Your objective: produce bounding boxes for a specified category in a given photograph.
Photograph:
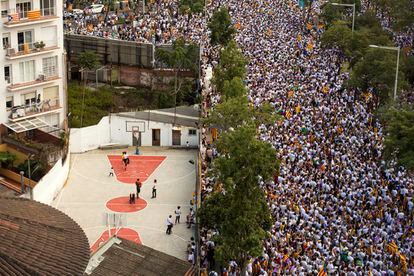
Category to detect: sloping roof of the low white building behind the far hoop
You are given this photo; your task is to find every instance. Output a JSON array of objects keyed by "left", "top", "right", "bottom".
[{"left": 117, "top": 106, "right": 199, "bottom": 128}]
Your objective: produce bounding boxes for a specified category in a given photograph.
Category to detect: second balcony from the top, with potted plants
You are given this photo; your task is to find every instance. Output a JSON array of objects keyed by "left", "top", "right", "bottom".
[{"left": 6, "top": 41, "right": 59, "bottom": 60}]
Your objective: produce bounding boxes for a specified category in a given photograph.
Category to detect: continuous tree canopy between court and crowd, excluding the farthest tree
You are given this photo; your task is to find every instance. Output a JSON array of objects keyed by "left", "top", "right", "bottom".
[{"left": 198, "top": 34, "right": 279, "bottom": 269}]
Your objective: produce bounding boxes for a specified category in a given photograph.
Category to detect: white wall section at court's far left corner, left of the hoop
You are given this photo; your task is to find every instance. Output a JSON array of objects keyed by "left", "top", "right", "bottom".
[{"left": 69, "top": 116, "right": 110, "bottom": 153}]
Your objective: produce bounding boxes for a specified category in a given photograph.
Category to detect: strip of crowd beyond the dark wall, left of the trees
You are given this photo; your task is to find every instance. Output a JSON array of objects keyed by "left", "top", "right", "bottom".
[{"left": 64, "top": 0, "right": 206, "bottom": 44}]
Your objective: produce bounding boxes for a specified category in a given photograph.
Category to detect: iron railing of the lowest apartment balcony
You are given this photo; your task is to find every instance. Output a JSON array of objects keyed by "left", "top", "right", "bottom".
[{"left": 10, "top": 98, "right": 60, "bottom": 119}]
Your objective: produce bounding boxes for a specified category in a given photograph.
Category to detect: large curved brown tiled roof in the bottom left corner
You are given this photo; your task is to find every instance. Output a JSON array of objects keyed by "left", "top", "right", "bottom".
[{"left": 0, "top": 197, "right": 90, "bottom": 276}]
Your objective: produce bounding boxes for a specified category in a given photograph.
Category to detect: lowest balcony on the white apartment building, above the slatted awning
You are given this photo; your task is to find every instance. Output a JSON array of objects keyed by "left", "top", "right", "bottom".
[{"left": 9, "top": 99, "right": 62, "bottom": 122}]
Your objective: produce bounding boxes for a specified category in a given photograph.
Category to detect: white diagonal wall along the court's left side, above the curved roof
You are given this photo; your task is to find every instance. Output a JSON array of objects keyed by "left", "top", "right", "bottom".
[{"left": 33, "top": 153, "right": 70, "bottom": 204}]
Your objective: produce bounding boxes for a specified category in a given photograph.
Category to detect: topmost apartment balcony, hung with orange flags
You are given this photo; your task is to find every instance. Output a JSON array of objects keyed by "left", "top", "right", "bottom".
[{"left": 3, "top": 8, "right": 59, "bottom": 29}]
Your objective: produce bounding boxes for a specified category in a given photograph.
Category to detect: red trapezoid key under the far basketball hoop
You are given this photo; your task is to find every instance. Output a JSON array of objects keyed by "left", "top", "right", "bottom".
[{"left": 108, "top": 155, "right": 166, "bottom": 184}]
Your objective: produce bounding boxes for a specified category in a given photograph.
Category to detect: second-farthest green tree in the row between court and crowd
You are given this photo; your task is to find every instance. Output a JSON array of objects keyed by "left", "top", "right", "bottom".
[{"left": 213, "top": 40, "right": 247, "bottom": 92}]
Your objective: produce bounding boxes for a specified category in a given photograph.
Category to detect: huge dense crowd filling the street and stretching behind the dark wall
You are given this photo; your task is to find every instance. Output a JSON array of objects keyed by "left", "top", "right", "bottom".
[{"left": 65, "top": 0, "right": 414, "bottom": 275}]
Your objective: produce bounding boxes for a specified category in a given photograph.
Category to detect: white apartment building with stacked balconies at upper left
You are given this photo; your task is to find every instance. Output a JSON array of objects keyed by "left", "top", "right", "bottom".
[{"left": 0, "top": 0, "right": 66, "bottom": 133}]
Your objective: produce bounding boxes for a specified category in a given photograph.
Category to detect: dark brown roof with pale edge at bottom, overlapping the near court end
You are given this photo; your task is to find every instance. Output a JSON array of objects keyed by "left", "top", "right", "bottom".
[{"left": 85, "top": 237, "right": 193, "bottom": 276}]
